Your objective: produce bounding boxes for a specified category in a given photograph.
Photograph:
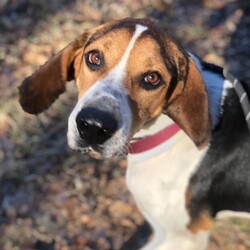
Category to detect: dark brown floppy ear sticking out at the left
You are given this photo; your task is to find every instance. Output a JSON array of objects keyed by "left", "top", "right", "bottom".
[{"left": 19, "top": 32, "right": 88, "bottom": 114}]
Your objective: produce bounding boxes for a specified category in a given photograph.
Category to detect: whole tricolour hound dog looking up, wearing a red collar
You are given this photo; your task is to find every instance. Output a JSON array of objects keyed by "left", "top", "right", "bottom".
[{"left": 19, "top": 19, "right": 250, "bottom": 250}]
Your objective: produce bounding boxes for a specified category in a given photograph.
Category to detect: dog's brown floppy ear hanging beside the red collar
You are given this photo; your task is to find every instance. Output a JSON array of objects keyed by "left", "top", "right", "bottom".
[{"left": 164, "top": 56, "right": 211, "bottom": 148}]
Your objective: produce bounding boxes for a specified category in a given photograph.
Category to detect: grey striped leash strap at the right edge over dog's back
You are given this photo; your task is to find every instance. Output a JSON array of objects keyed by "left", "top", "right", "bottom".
[{"left": 223, "top": 69, "right": 250, "bottom": 131}]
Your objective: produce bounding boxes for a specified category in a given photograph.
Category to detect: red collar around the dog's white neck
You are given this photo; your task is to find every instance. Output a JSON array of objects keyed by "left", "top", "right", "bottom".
[{"left": 129, "top": 123, "right": 180, "bottom": 154}]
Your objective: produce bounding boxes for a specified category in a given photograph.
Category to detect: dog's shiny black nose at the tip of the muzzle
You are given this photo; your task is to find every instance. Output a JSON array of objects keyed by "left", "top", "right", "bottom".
[{"left": 76, "top": 107, "right": 118, "bottom": 146}]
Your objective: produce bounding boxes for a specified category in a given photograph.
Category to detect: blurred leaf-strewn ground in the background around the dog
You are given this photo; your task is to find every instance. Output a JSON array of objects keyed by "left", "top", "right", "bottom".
[{"left": 0, "top": 0, "right": 250, "bottom": 250}]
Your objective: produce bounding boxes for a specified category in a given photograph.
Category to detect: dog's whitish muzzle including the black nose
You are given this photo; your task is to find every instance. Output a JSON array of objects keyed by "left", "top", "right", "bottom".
[{"left": 68, "top": 84, "right": 132, "bottom": 158}]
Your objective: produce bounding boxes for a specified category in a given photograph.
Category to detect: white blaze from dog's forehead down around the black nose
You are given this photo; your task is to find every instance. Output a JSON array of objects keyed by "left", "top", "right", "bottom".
[{"left": 68, "top": 24, "right": 148, "bottom": 157}]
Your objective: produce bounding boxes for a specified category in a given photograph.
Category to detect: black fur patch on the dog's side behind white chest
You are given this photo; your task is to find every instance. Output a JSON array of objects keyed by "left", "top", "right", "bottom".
[{"left": 188, "top": 89, "right": 250, "bottom": 219}]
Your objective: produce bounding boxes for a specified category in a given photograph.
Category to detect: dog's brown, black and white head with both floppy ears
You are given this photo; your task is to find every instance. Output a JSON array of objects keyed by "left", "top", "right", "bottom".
[{"left": 19, "top": 19, "right": 210, "bottom": 157}]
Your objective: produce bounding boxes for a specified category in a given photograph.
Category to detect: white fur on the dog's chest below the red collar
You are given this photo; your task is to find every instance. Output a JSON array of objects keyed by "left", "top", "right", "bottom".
[{"left": 126, "top": 131, "right": 208, "bottom": 250}]
